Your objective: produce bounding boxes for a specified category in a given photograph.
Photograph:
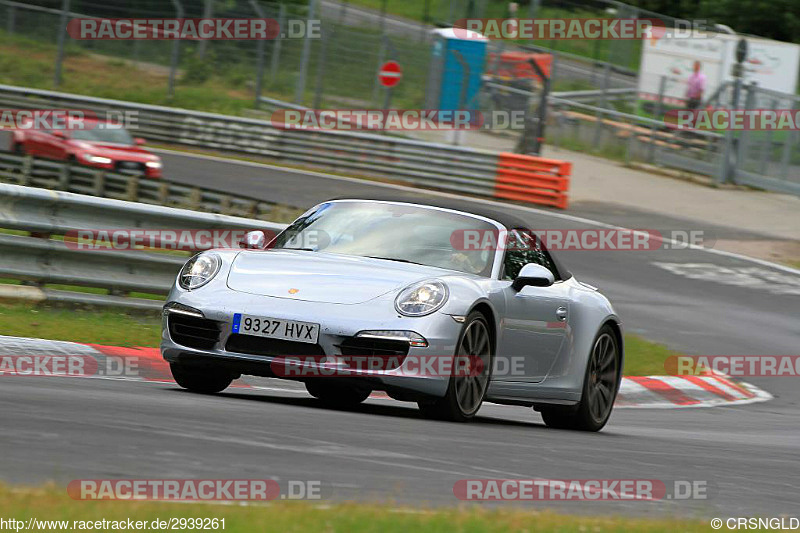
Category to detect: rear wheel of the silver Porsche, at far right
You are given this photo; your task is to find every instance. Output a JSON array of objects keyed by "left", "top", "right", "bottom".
[{"left": 541, "top": 325, "right": 620, "bottom": 431}]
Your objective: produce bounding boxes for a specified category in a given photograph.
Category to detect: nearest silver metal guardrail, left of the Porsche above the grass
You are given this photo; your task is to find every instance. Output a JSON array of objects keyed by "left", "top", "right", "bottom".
[{"left": 0, "top": 184, "right": 285, "bottom": 307}]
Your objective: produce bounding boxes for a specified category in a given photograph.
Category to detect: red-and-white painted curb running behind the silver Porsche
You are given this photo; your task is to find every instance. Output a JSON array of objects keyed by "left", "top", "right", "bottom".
[{"left": 0, "top": 335, "right": 772, "bottom": 409}]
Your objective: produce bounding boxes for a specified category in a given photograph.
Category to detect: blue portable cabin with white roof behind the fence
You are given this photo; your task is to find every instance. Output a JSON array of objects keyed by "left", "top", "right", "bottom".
[{"left": 427, "top": 28, "right": 488, "bottom": 110}]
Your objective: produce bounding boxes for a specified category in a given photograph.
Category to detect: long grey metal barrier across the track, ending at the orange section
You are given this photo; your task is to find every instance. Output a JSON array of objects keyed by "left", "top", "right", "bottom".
[{"left": 0, "top": 85, "right": 566, "bottom": 206}]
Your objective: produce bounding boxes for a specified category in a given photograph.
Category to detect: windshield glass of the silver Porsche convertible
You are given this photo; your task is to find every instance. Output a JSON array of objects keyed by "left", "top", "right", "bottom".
[{"left": 273, "top": 202, "right": 497, "bottom": 276}]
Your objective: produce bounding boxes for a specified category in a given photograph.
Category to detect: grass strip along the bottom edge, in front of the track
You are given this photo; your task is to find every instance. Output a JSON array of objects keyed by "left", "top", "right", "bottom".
[{"left": 0, "top": 485, "right": 709, "bottom": 533}]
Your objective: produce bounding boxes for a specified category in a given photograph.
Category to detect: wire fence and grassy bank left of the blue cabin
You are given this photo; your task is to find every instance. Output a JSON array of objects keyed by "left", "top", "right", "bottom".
[{"left": 0, "top": 0, "right": 438, "bottom": 109}]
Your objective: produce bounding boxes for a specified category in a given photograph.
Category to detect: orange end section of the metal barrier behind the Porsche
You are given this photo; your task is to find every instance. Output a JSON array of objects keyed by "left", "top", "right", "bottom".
[{"left": 494, "top": 153, "right": 572, "bottom": 209}]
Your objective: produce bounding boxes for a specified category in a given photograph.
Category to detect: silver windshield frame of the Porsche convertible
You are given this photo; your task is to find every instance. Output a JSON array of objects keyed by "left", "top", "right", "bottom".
[{"left": 267, "top": 199, "right": 507, "bottom": 279}]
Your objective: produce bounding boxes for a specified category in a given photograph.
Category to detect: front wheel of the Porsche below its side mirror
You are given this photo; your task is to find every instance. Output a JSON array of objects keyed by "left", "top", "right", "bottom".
[{"left": 418, "top": 311, "right": 493, "bottom": 422}]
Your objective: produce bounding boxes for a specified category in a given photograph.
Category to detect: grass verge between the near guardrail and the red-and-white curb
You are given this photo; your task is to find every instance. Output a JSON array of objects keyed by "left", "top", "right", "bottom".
[{"left": 0, "top": 304, "right": 676, "bottom": 376}]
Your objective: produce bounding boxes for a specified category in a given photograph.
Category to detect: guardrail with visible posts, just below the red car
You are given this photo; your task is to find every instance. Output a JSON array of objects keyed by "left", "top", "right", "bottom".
[{"left": 0, "top": 152, "right": 289, "bottom": 220}]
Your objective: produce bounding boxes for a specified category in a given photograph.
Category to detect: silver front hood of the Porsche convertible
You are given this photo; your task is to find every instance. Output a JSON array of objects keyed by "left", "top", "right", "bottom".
[{"left": 228, "top": 250, "right": 452, "bottom": 304}]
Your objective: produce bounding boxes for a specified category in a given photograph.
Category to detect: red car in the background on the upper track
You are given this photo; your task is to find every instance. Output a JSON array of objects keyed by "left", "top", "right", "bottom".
[{"left": 11, "top": 121, "right": 162, "bottom": 178}]
